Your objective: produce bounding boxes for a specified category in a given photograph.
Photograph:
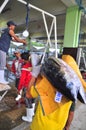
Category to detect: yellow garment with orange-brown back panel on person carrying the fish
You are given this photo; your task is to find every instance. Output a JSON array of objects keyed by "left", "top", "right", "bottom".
[{"left": 30, "top": 77, "right": 72, "bottom": 130}]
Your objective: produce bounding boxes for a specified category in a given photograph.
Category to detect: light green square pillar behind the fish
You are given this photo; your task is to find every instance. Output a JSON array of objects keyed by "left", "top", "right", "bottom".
[{"left": 63, "top": 6, "right": 81, "bottom": 48}]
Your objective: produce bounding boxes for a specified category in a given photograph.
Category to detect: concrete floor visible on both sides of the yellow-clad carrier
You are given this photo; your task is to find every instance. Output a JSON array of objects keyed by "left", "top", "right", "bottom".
[{"left": 0, "top": 81, "right": 86, "bottom": 130}]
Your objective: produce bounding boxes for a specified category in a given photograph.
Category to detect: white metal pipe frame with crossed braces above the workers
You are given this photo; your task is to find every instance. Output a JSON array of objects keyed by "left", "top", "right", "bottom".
[{"left": 17, "top": 0, "right": 57, "bottom": 57}]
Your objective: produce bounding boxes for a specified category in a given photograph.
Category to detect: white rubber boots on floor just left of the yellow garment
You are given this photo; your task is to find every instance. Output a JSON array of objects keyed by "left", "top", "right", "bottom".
[{"left": 22, "top": 108, "right": 33, "bottom": 122}]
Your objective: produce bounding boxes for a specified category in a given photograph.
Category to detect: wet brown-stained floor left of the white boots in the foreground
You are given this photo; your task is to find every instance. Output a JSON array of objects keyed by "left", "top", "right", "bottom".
[{"left": 0, "top": 82, "right": 25, "bottom": 130}]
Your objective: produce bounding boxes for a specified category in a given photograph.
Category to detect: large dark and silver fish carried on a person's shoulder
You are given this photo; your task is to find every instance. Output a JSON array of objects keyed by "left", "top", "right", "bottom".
[{"left": 42, "top": 57, "right": 86, "bottom": 103}]
